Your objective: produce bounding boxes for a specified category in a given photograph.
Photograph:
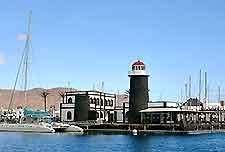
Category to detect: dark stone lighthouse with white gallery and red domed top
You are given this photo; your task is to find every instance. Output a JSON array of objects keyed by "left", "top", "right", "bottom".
[{"left": 128, "top": 60, "right": 149, "bottom": 124}]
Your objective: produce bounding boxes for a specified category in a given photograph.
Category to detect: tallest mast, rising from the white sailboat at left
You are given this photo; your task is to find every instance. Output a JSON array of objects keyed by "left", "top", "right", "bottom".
[{"left": 24, "top": 11, "right": 32, "bottom": 107}]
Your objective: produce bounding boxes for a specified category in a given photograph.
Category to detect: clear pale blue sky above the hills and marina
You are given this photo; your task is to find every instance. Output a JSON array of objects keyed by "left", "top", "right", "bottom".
[{"left": 0, "top": 0, "right": 225, "bottom": 101}]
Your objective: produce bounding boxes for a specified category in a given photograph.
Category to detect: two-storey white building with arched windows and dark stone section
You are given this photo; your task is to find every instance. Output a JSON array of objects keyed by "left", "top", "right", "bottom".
[{"left": 60, "top": 91, "right": 116, "bottom": 122}]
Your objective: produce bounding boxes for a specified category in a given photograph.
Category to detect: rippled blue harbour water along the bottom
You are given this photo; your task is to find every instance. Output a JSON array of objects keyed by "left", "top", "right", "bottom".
[{"left": 0, "top": 132, "right": 225, "bottom": 152}]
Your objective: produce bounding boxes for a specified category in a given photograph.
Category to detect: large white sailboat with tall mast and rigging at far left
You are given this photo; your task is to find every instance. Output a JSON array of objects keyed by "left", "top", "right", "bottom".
[{"left": 0, "top": 12, "right": 55, "bottom": 133}]
